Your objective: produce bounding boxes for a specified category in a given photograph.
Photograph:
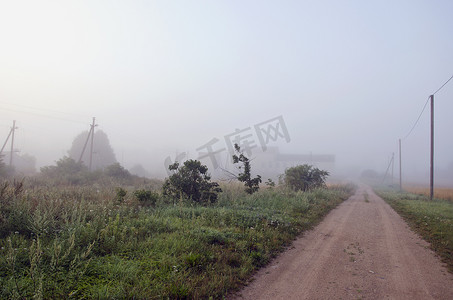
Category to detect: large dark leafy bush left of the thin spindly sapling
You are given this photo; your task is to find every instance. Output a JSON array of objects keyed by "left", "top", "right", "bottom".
[{"left": 162, "top": 159, "right": 222, "bottom": 203}]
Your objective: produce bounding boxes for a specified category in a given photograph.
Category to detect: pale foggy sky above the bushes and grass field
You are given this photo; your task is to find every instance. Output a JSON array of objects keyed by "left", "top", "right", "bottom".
[{"left": 0, "top": 1, "right": 453, "bottom": 185}]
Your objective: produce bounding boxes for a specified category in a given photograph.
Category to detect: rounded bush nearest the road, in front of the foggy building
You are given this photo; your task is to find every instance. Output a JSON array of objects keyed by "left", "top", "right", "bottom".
[{"left": 284, "top": 164, "right": 329, "bottom": 191}]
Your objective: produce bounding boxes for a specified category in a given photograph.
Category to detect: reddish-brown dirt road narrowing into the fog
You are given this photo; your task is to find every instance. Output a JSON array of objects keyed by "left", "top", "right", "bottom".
[{"left": 233, "top": 186, "right": 453, "bottom": 300}]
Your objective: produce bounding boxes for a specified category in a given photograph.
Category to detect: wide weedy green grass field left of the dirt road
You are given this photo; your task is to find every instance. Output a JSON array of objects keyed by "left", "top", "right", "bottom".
[{"left": 0, "top": 179, "right": 352, "bottom": 299}]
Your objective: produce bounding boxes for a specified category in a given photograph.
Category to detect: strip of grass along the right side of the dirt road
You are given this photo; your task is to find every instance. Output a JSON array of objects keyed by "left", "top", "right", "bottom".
[{"left": 376, "top": 190, "right": 453, "bottom": 272}]
